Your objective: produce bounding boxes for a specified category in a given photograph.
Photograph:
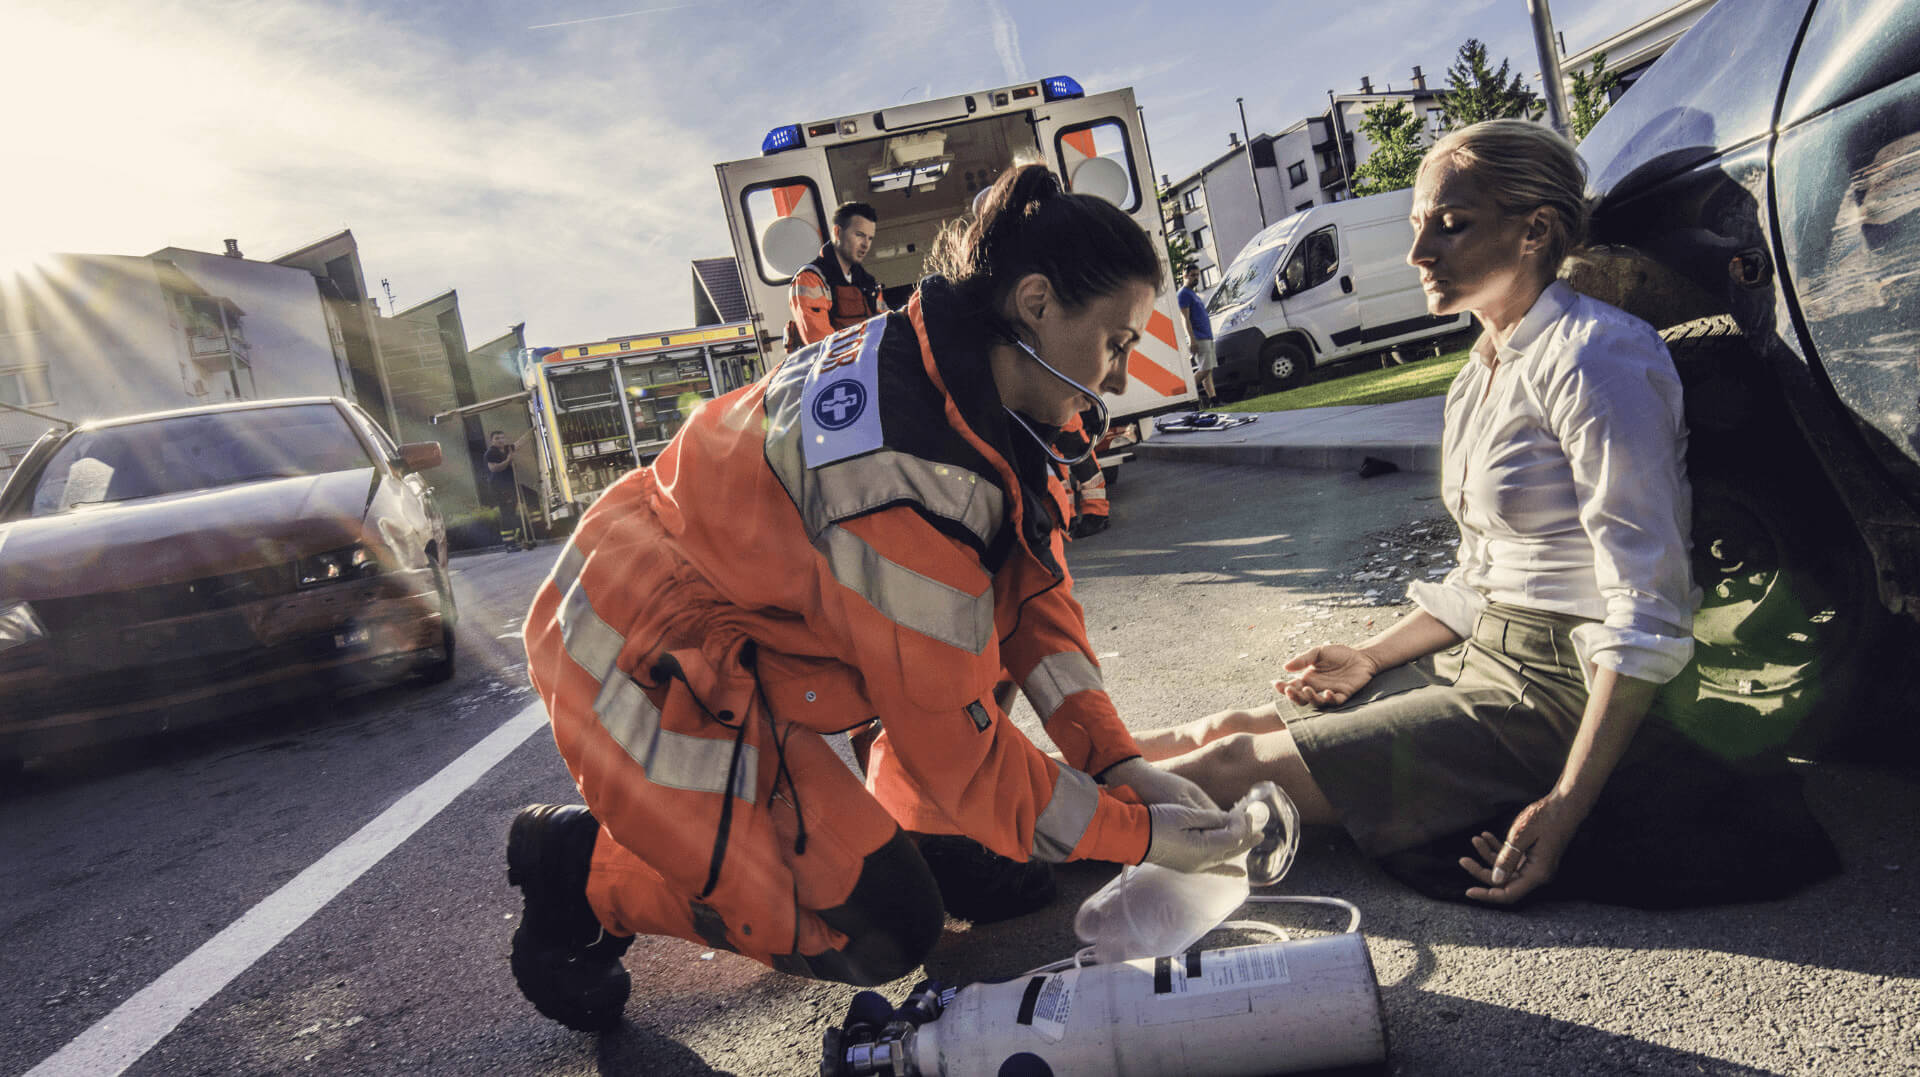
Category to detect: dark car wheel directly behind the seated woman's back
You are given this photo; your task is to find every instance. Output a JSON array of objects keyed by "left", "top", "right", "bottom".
[{"left": 1661, "top": 326, "right": 1899, "bottom": 758}]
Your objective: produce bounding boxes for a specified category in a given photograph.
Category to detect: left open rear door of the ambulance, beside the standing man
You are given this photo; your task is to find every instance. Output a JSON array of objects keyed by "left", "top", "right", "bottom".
[{"left": 714, "top": 146, "right": 833, "bottom": 369}]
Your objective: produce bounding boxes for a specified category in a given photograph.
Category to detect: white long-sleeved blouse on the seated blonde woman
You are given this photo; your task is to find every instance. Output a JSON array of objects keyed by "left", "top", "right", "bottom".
[{"left": 1411, "top": 280, "right": 1699, "bottom": 683}]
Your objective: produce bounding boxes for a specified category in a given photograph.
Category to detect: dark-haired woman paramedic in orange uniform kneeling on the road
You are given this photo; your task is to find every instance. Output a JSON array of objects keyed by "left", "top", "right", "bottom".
[{"left": 507, "top": 165, "right": 1258, "bottom": 1029}]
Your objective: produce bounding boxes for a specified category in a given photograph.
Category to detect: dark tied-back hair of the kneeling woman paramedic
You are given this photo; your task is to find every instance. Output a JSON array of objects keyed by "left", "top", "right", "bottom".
[{"left": 927, "top": 165, "right": 1165, "bottom": 317}]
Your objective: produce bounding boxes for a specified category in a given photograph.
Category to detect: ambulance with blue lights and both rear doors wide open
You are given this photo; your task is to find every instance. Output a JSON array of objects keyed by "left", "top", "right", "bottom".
[{"left": 714, "top": 75, "right": 1198, "bottom": 437}]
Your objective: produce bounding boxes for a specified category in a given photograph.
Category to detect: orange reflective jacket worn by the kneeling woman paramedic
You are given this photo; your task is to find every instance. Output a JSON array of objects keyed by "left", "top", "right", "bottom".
[{"left": 582, "top": 276, "right": 1148, "bottom": 864}]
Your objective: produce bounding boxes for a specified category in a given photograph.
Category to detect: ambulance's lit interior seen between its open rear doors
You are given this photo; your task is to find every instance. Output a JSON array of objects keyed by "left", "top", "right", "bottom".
[{"left": 828, "top": 113, "right": 1041, "bottom": 301}]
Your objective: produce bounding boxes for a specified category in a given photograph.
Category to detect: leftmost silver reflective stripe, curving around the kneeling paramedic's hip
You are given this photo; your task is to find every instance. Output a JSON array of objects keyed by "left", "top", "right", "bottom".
[{"left": 553, "top": 543, "right": 760, "bottom": 804}]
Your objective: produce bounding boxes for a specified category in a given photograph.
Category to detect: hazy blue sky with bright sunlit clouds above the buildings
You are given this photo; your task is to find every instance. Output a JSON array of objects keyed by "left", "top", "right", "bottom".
[{"left": 0, "top": 0, "right": 1670, "bottom": 346}]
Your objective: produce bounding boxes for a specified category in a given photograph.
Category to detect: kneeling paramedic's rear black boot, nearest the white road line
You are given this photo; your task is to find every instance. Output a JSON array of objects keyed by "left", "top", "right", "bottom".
[{"left": 507, "top": 804, "right": 634, "bottom": 1033}]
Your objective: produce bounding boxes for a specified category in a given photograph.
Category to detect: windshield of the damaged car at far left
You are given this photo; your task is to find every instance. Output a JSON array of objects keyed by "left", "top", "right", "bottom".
[{"left": 33, "top": 403, "right": 372, "bottom": 516}]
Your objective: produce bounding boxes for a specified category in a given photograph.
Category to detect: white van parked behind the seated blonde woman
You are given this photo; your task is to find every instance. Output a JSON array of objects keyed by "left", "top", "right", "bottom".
[{"left": 1206, "top": 190, "right": 1471, "bottom": 394}]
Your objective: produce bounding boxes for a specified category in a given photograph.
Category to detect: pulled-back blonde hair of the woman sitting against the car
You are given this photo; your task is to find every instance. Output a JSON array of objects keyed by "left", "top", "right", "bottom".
[{"left": 1419, "top": 119, "right": 1590, "bottom": 273}]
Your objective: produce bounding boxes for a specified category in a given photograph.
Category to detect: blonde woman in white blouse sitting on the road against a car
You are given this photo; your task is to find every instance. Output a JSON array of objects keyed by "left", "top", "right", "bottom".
[{"left": 1140, "top": 121, "right": 1695, "bottom": 902}]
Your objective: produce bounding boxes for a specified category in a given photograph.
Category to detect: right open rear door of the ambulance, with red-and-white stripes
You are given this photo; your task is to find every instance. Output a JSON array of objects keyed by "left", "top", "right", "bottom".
[{"left": 1033, "top": 90, "right": 1198, "bottom": 424}]
